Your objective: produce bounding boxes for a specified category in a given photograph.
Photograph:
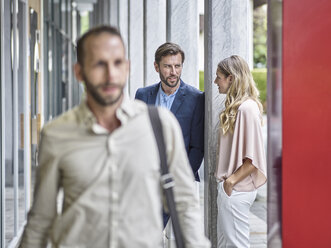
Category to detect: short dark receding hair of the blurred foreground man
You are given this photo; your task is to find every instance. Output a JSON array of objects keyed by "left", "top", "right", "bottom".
[{"left": 77, "top": 25, "right": 124, "bottom": 65}]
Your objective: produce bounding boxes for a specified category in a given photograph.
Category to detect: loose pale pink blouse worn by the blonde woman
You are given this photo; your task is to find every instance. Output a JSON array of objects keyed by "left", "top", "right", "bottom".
[{"left": 215, "top": 99, "right": 267, "bottom": 192}]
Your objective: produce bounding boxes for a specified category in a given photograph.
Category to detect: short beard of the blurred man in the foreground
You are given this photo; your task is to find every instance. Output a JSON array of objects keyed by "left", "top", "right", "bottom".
[{"left": 83, "top": 75, "right": 124, "bottom": 106}]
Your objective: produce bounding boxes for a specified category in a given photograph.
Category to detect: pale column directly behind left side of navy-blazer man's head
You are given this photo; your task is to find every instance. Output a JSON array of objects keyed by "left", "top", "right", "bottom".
[{"left": 144, "top": 0, "right": 166, "bottom": 86}]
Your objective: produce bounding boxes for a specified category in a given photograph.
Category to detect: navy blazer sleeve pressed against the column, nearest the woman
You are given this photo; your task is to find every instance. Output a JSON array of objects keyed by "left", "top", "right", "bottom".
[{"left": 188, "top": 93, "right": 205, "bottom": 179}]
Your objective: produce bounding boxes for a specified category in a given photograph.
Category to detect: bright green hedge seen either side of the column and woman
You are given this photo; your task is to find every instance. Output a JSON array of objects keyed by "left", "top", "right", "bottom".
[{"left": 199, "top": 68, "right": 267, "bottom": 111}]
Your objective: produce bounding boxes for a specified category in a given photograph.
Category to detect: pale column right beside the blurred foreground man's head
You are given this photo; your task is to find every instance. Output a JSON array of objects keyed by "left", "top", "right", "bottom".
[{"left": 128, "top": 0, "right": 144, "bottom": 98}]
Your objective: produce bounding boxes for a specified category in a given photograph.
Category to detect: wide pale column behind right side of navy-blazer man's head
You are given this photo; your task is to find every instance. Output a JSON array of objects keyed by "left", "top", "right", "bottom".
[{"left": 167, "top": 0, "right": 199, "bottom": 88}]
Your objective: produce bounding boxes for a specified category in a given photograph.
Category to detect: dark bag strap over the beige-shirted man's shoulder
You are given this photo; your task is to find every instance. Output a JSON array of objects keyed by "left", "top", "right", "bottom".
[{"left": 148, "top": 106, "right": 185, "bottom": 248}]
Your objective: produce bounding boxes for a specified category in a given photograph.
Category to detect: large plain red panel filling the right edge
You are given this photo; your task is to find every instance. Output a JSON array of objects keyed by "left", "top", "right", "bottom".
[{"left": 282, "top": 0, "right": 331, "bottom": 248}]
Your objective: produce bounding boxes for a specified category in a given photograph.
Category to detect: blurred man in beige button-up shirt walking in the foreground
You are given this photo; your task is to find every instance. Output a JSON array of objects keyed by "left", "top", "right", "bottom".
[{"left": 21, "top": 26, "right": 210, "bottom": 248}]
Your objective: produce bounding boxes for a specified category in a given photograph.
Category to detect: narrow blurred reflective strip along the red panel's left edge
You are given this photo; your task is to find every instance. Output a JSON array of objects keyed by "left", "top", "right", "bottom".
[{"left": 267, "top": 0, "right": 282, "bottom": 248}]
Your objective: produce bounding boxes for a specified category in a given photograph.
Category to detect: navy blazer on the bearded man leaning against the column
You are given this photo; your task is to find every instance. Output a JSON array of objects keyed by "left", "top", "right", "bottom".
[{"left": 135, "top": 80, "right": 205, "bottom": 181}]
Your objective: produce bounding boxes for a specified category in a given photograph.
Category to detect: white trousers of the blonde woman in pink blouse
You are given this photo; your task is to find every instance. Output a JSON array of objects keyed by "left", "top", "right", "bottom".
[{"left": 217, "top": 182, "right": 257, "bottom": 248}]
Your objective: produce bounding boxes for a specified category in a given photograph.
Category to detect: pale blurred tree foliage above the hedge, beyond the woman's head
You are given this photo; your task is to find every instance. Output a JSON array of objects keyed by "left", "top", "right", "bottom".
[{"left": 253, "top": 5, "right": 267, "bottom": 68}]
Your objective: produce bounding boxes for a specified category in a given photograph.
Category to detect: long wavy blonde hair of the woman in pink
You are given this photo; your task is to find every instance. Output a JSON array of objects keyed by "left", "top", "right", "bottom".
[{"left": 217, "top": 55, "right": 263, "bottom": 134}]
